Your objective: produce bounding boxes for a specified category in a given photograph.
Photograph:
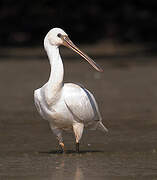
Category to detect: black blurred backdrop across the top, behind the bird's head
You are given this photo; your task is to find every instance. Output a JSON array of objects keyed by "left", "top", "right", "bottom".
[{"left": 0, "top": 0, "right": 157, "bottom": 46}]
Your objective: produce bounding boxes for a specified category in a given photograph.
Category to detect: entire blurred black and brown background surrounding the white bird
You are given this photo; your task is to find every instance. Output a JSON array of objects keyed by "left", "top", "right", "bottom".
[{"left": 0, "top": 0, "right": 157, "bottom": 180}]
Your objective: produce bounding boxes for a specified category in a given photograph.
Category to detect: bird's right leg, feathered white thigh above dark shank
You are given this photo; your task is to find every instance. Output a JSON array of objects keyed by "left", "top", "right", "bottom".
[{"left": 73, "top": 122, "right": 84, "bottom": 153}]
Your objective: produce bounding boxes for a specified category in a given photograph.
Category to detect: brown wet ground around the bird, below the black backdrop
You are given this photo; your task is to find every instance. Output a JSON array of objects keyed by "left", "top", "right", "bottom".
[{"left": 0, "top": 46, "right": 157, "bottom": 180}]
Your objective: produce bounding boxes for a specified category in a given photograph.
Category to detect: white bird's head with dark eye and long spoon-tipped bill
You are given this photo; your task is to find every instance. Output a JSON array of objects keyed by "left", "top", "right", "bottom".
[{"left": 44, "top": 28, "right": 103, "bottom": 72}]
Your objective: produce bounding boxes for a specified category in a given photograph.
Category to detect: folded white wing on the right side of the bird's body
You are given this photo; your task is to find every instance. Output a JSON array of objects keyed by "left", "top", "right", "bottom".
[{"left": 64, "top": 83, "right": 101, "bottom": 122}]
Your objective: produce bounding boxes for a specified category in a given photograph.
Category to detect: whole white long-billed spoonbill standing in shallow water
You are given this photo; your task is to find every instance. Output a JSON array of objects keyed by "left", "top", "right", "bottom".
[{"left": 34, "top": 28, "right": 108, "bottom": 152}]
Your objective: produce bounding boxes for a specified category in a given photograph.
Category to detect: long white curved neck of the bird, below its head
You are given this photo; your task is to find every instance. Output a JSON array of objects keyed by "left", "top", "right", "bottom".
[{"left": 45, "top": 46, "right": 64, "bottom": 104}]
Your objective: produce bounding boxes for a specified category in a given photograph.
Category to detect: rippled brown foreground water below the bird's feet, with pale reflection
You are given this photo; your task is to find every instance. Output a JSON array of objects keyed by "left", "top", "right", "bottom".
[{"left": 0, "top": 152, "right": 157, "bottom": 180}]
